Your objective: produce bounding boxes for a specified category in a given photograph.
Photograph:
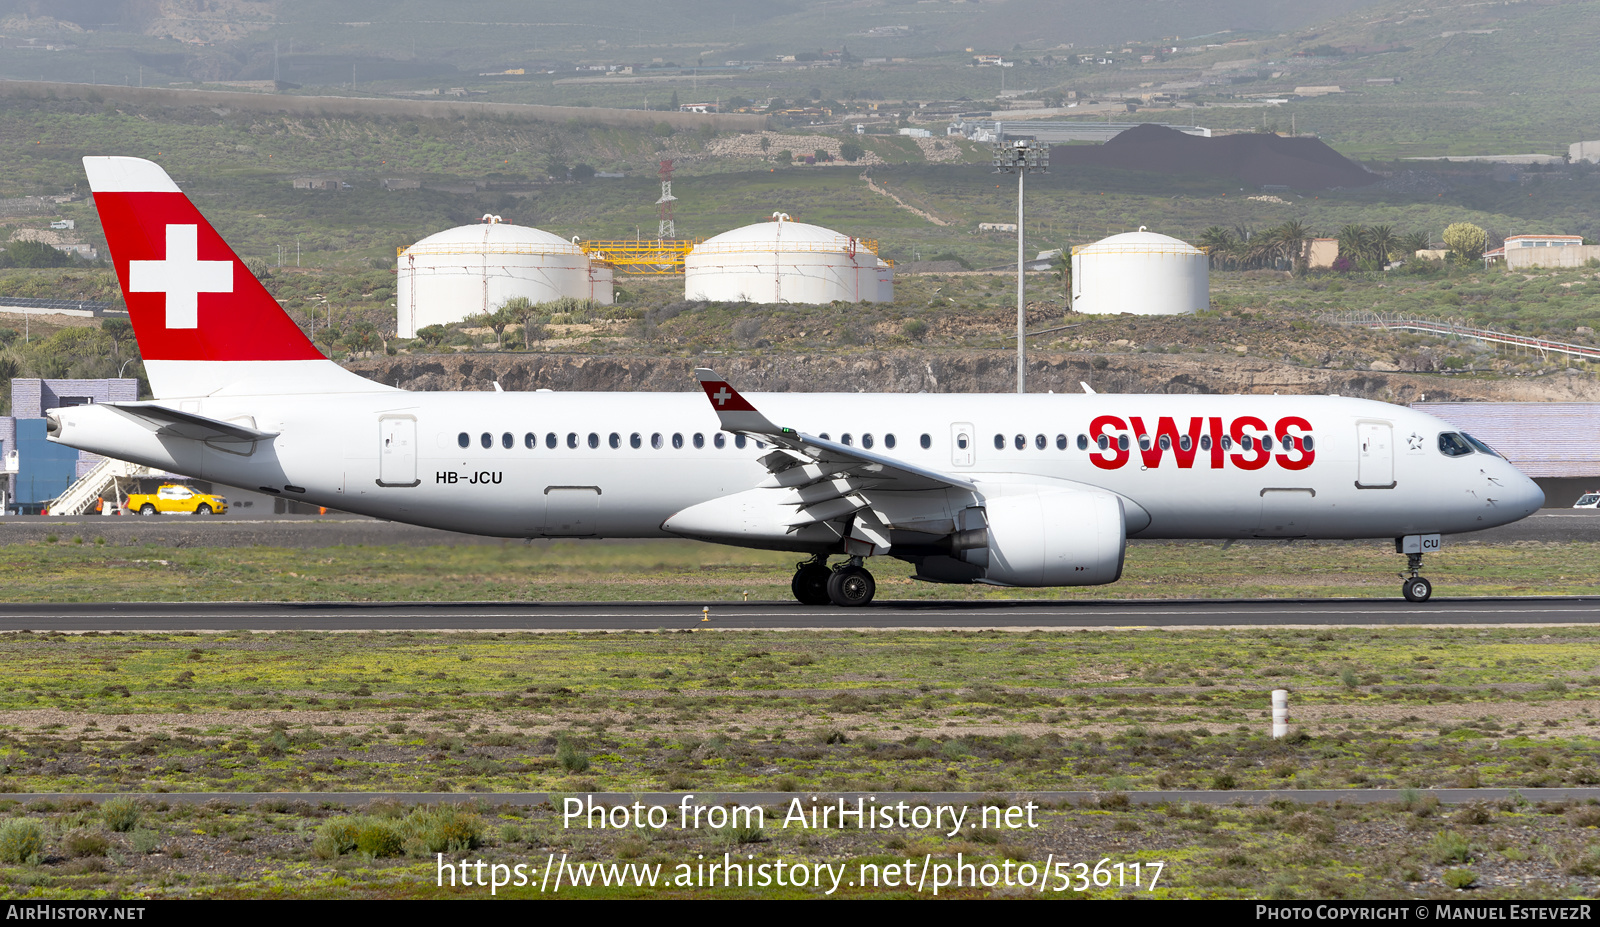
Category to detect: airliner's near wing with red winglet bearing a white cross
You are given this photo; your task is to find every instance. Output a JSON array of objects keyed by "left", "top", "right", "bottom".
[{"left": 694, "top": 367, "right": 976, "bottom": 492}]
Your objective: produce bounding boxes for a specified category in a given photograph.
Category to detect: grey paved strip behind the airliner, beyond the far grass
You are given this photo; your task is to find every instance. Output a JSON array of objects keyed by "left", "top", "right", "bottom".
[{"left": 0, "top": 509, "right": 1600, "bottom": 548}]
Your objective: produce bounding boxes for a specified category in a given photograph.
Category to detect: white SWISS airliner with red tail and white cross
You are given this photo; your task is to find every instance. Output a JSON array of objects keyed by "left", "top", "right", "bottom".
[{"left": 48, "top": 157, "right": 1544, "bottom": 605}]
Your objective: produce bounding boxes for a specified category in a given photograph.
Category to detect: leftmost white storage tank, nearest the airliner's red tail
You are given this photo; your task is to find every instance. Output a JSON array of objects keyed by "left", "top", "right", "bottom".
[{"left": 395, "top": 216, "right": 611, "bottom": 338}]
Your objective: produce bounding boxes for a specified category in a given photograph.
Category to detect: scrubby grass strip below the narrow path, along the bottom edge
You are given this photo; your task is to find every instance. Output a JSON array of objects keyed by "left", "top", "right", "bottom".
[{"left": 0, "top": 793, "right": 1600, "bottom": 901}]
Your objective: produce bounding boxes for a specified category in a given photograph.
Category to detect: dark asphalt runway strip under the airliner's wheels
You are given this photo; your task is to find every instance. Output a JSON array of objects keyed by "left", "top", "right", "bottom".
[{"left": 0, "top": 597, "right": 1600, "bottom": 631}]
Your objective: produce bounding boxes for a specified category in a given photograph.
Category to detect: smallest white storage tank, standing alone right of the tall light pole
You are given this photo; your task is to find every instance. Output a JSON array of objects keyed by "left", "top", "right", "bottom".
[{"left": 1072, "top": 226, "right": 1211, "bottom": 315}]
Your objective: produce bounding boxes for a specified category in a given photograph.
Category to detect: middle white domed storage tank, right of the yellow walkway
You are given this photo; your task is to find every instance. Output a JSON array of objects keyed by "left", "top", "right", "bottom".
[{"left": 683, "top": 213, "right": 893, "bottom": 303}]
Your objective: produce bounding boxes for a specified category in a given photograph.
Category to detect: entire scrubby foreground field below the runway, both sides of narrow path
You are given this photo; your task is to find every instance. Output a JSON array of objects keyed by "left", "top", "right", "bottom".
[{"left": 0, "top": 628, "right": 1600, "bottom": 898}]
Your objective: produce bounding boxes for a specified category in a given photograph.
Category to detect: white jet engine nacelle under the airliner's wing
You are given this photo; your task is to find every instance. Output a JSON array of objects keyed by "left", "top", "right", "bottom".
[{"left": 957, "top": 490, "right": 1128, "bottom": 586}]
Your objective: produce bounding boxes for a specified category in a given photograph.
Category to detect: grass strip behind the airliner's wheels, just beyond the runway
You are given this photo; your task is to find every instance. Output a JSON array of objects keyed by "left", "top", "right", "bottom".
[{"left": 0, "top": 533, "right": 1600, "bottom": 604}]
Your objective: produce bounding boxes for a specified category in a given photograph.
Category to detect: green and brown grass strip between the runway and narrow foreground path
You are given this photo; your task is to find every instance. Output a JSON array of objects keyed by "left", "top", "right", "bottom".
[{"left": 0, "top": 621, "right": 1600, "bottom": 794}]
